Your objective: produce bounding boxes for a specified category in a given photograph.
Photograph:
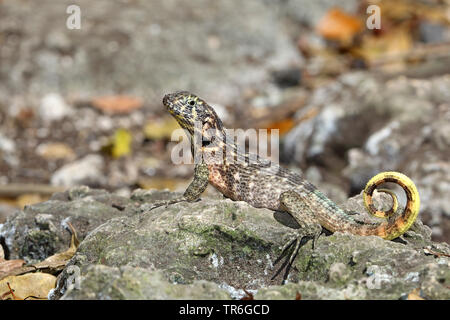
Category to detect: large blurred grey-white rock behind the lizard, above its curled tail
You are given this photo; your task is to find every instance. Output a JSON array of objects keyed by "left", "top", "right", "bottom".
[{"left": 283, "top": 72, "right": 444, "bottom": 168}]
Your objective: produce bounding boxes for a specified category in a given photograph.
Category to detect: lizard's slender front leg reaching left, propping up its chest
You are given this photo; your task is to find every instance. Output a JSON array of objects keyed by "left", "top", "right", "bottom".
[{"left": 142, "top": 163, "right": 209, "bottom": 211}]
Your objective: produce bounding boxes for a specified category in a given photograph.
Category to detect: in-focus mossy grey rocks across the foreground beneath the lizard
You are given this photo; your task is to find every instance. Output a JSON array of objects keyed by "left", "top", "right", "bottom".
[{"left": 0, "top": 187, "right": 450, "bottom": 299}]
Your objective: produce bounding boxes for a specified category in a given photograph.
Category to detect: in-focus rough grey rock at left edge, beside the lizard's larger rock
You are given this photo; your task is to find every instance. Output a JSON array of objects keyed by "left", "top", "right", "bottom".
[{"left": 0, "top": 187, "right": 133, "bottom": 263}]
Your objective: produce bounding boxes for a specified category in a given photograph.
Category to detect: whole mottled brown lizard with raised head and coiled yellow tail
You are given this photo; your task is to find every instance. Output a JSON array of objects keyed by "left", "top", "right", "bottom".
[{"left": 155, "top": 91, "right": 420, "bottom": 283}]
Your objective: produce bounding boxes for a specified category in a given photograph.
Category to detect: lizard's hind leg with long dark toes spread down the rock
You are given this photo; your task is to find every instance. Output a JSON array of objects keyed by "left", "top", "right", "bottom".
[{"left": 272, "top": 191, "right": 322, "bottom": 283}]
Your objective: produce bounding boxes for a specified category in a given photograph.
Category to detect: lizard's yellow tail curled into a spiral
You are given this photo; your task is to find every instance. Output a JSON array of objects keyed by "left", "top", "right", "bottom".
[{"left": 363, "top": 171, "right": 420, "bottom": 240}]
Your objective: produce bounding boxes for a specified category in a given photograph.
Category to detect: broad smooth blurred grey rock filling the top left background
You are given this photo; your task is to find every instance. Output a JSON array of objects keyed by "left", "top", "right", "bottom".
[{"left": 0, "top": 0, "right": 301, "bottom": 105}]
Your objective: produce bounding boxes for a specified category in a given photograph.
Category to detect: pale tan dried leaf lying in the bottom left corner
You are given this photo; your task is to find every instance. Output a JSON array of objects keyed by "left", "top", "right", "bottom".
[{"left": 0, "top": 272, "right": 56, "bottom": 300}]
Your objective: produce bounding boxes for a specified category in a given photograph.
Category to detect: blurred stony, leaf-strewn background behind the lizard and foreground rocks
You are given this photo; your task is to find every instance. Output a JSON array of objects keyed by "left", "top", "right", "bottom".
[{"left": 0, "top": 0, "right": 450, "bottom": 242}]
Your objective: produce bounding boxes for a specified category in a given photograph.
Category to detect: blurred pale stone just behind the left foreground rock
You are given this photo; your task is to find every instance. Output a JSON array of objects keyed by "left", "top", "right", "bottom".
[{"left": 50, "top": 154, "right": 104, "bottom": 187}]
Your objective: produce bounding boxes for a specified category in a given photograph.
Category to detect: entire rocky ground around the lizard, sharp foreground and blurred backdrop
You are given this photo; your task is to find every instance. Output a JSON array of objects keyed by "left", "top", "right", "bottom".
[{"left": 0, "top": 0, "right": 450, "bottom": 299}]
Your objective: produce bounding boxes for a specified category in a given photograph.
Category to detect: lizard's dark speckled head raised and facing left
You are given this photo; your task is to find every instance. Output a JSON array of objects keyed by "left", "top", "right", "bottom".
[{"left": 163, "top": 91, "right": 223, "bottom": 135}]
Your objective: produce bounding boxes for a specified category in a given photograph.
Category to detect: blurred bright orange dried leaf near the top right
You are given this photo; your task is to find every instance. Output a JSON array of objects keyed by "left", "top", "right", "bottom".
[{"left": 316, "top": 8, "right": 362, "bottom": 44}]
